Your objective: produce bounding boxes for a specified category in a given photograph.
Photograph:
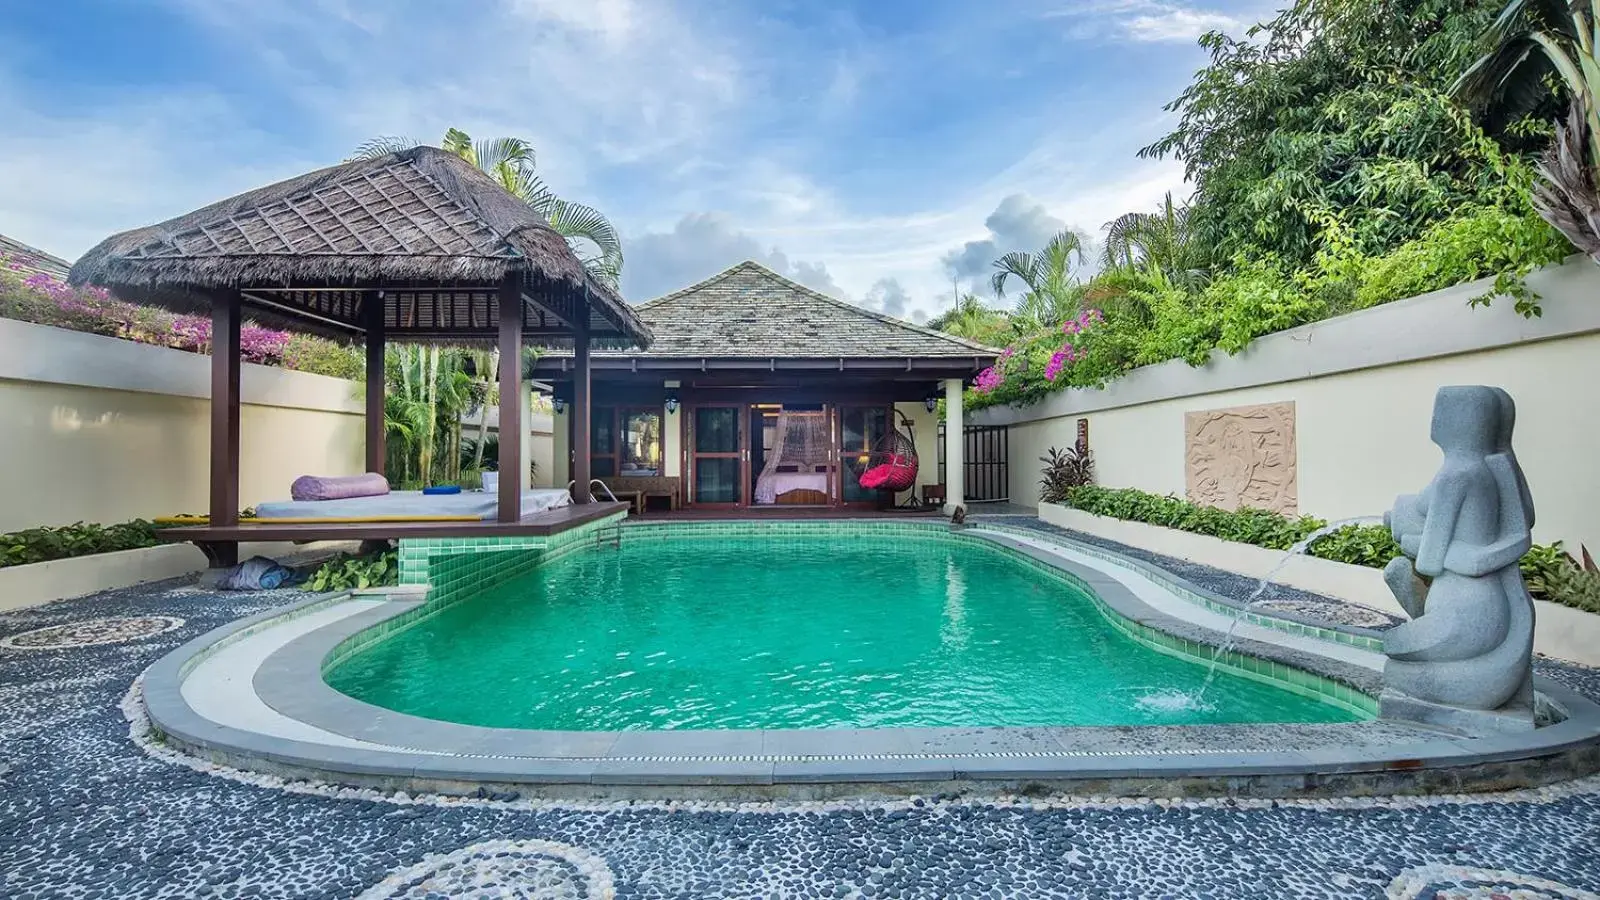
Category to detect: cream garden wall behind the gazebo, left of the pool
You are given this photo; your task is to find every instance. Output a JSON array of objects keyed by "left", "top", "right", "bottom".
[{"left": 0, "top": 319, "right": 365, "bottom": 532}]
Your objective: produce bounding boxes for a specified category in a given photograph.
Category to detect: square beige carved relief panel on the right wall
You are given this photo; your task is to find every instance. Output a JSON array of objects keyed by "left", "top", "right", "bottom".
[{"left": 1184, "top": 402, "right": 1299, "bottom": 514}]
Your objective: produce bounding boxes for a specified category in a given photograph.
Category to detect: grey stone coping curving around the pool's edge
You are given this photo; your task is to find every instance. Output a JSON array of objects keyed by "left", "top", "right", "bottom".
[{"left": 134, "top": 518, "right": 1600, "bottom": 796}]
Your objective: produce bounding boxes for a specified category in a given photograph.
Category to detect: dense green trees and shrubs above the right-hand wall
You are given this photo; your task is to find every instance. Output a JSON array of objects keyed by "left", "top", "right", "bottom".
[{"left": 931, "top": 0, "right": 1574, "bottom": 407}]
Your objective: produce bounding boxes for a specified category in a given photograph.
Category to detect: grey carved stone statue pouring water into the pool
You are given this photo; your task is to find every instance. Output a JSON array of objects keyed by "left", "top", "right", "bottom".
[{"left": 1381, "top": 386, "right": 1533, "bottom": 732}]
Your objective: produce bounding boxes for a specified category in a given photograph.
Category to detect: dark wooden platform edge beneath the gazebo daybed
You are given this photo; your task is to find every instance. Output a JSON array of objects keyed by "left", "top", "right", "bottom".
[{"left": 157, "top": 503, "right": 629, "bottom": 565}]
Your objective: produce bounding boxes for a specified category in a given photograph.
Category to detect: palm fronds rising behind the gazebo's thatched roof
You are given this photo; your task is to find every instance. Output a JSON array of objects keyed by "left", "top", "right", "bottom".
[{"left": 346, "top": 128, "right": 622, "bottom": 287}]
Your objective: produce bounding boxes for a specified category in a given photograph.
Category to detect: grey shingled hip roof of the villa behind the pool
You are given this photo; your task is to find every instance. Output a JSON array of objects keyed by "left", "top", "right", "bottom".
[{"left": 620, "top": 261, "right": 997, "bottom": 359}]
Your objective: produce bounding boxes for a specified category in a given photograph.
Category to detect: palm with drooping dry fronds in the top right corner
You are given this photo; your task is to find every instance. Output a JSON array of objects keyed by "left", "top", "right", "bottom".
[{"left": 1454, "top": 0, "right": 1600, "bottom": 263}]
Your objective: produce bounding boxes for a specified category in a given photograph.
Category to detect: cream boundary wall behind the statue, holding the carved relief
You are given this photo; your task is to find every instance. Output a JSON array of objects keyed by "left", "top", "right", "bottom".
[{"left": 973, "top": 259, "right": 1600, "bottom": 549}]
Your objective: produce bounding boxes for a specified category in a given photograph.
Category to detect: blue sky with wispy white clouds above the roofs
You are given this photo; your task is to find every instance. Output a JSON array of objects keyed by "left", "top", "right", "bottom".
[{"left": 0, "top": 0, "right": 1272, "bottom": 317}]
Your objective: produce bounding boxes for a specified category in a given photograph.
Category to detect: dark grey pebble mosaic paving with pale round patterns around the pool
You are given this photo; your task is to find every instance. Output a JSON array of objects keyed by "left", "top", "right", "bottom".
[{"left": 0, "top": 573, "right": 1600, "bottom": 900}]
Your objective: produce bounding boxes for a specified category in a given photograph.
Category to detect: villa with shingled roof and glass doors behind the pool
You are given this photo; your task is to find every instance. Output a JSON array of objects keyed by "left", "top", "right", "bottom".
[{"left": 534, "top": 261, "right": 995, "bottom": 509}]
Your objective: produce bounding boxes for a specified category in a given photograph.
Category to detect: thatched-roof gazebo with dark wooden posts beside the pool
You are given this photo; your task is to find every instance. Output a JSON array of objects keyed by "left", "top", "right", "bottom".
[{"left": 70, "top": 147, "right": 651, "bottom": 557}]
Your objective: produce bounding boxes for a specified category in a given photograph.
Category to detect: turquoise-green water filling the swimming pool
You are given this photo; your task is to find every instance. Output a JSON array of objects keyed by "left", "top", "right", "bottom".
[{"left": 325, "top": 536, "right": 1360, "bottom": 730}]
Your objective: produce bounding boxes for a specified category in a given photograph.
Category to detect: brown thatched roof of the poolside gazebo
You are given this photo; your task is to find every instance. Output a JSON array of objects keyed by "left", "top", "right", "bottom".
[{"left": 70, "top": 147, "right": 650, "bottom": 346}]
